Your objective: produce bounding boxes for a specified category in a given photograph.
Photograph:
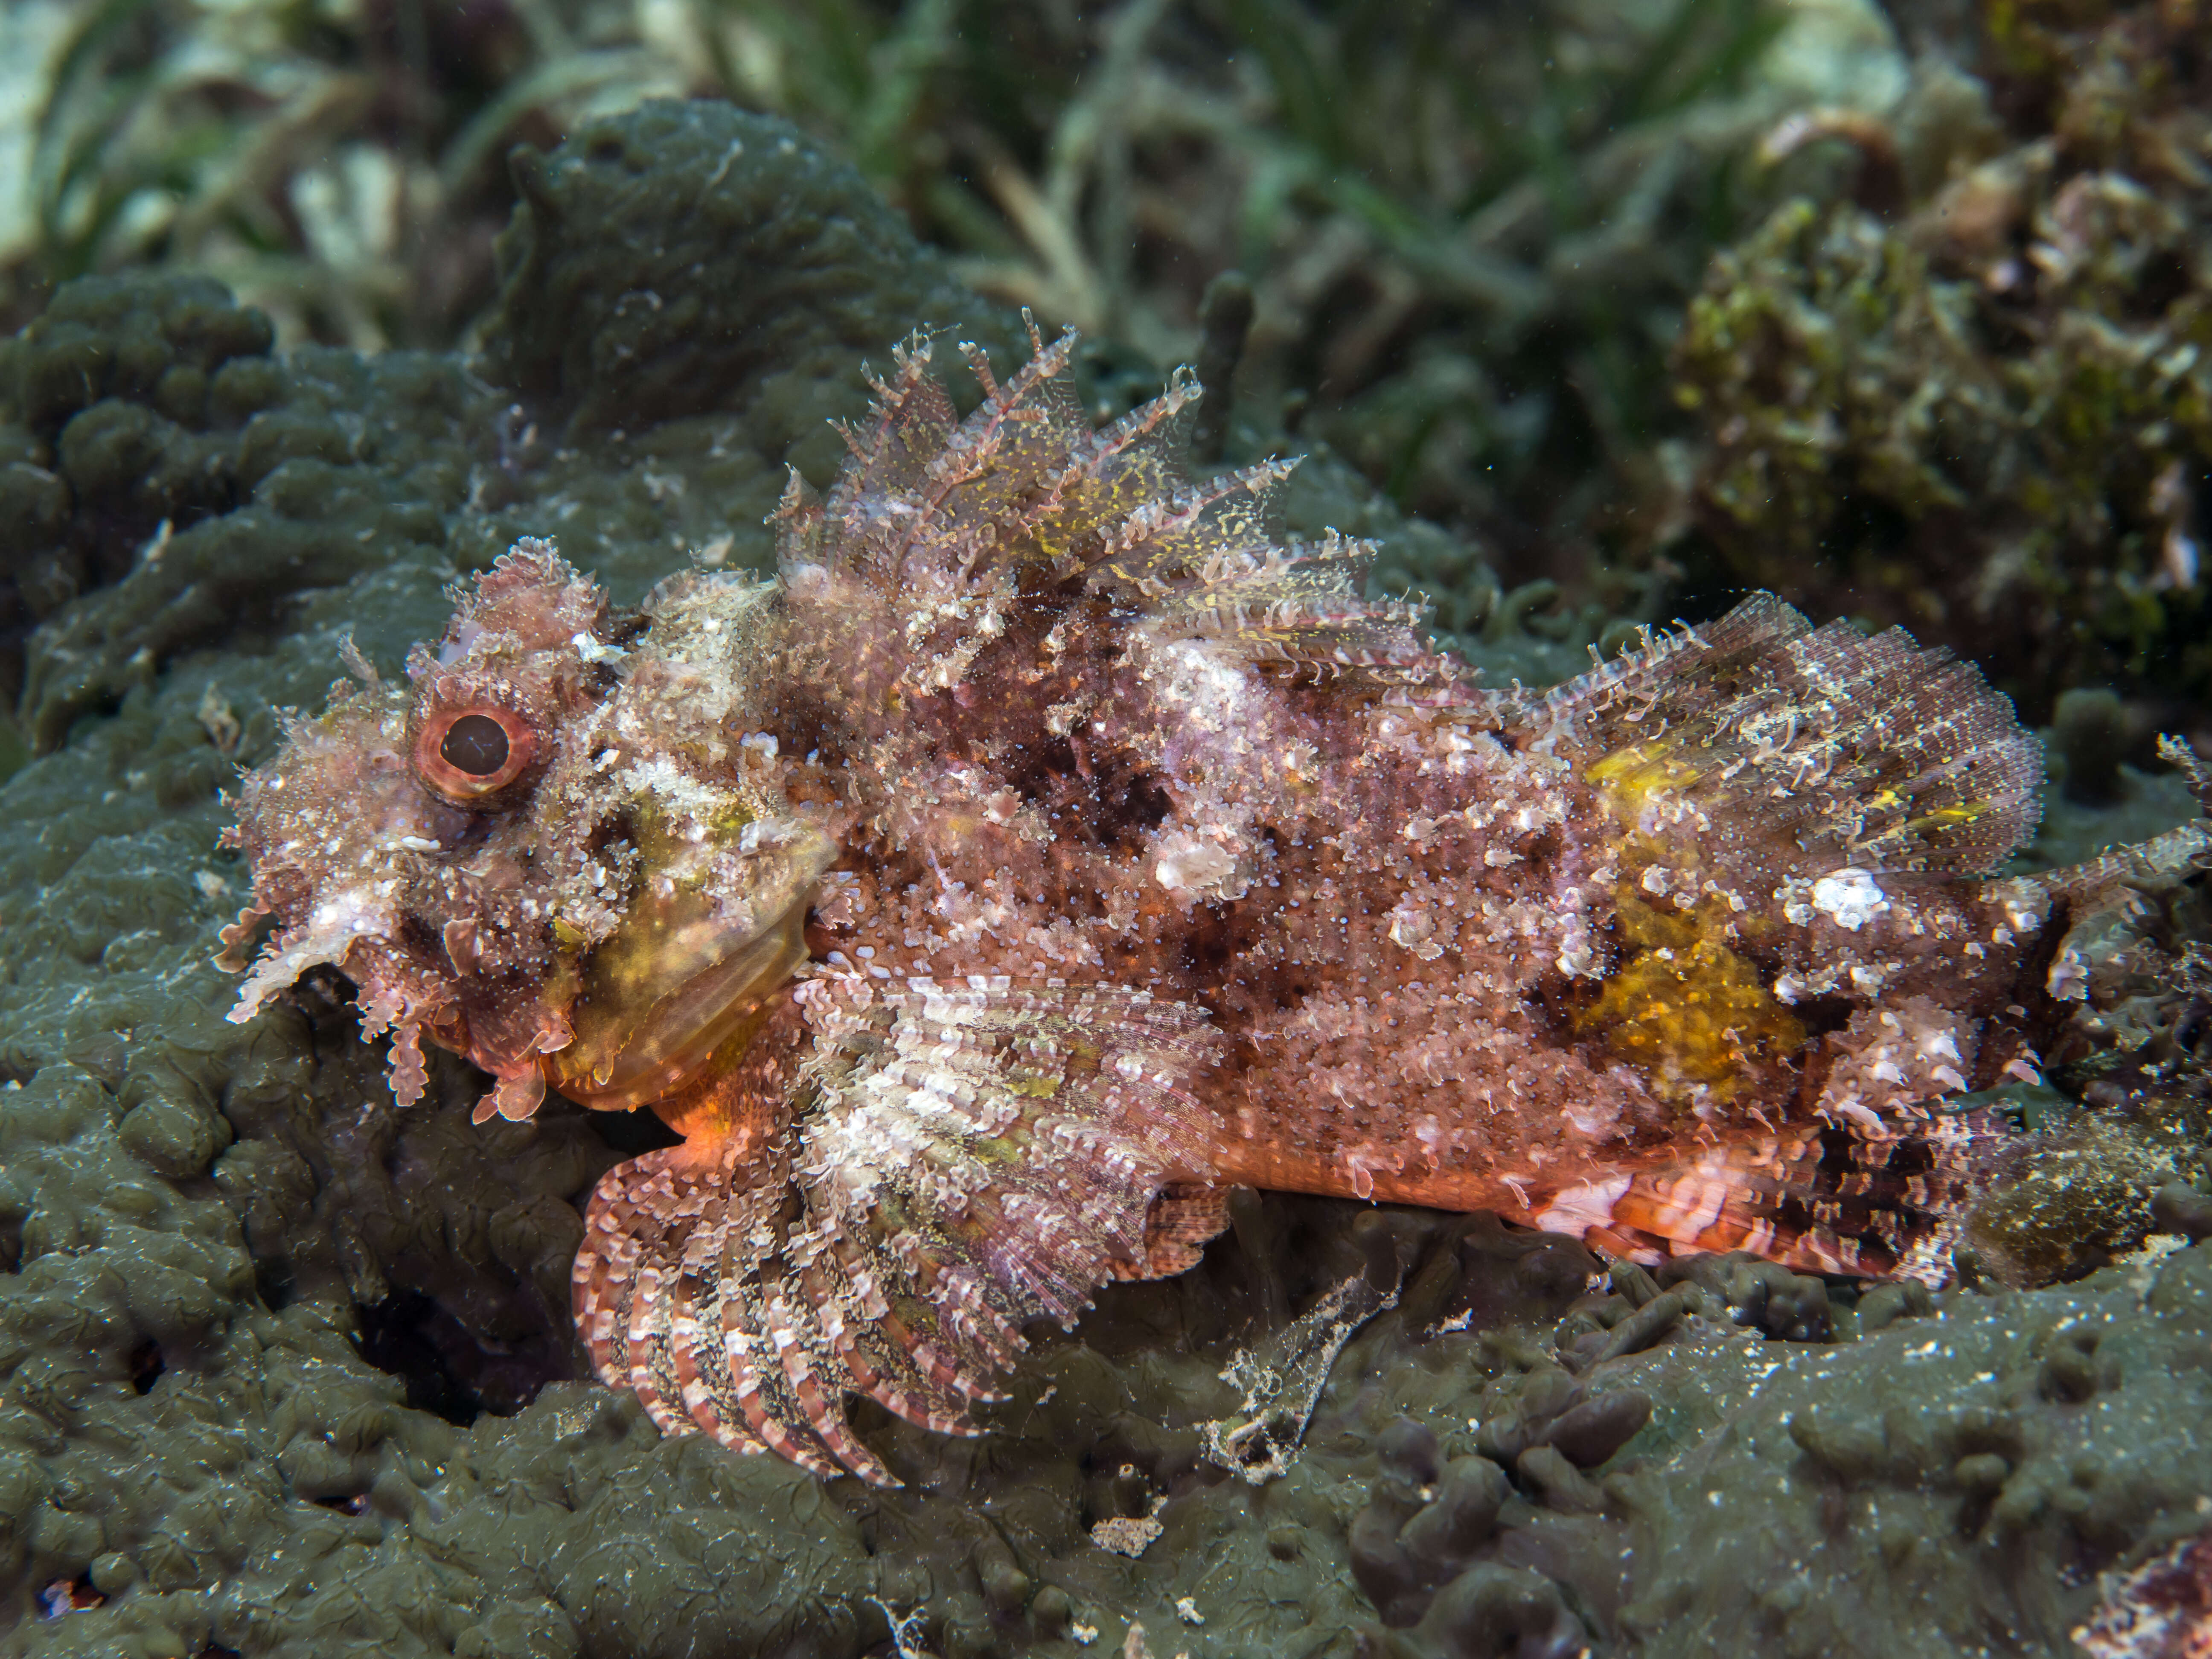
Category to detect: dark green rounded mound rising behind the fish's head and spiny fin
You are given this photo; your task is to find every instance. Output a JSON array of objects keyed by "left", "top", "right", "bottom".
[{"left": 484, "top": 104, "right": 1020, "bottom": 455}]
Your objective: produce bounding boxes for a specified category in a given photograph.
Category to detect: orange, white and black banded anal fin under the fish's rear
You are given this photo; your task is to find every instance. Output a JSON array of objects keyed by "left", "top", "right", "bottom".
[{"left": 1526, "top": 1113, "right": 2020, "bottom": 1285}]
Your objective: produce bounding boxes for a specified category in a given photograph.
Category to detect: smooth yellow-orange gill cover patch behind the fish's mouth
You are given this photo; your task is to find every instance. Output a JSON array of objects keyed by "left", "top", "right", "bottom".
[{"left": 540, "top": 832, "right": 834, "bottom": 1113}]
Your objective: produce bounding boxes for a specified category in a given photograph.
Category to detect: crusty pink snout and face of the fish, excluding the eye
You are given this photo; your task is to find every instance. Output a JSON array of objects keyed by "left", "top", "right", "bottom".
[{"left": 226, "top": 544, "right": 628, "bottom": 1115}]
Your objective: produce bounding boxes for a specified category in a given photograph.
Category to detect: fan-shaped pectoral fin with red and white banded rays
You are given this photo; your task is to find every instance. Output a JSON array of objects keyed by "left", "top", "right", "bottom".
[{"left": 573, "top": 980, "right": 1223, "bottom": 1484}]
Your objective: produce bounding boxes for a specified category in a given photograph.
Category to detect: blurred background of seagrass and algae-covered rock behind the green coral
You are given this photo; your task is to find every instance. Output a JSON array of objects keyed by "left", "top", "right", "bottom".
[{"left": 0, "top": 0, "right": 2212, "bottom": 759}]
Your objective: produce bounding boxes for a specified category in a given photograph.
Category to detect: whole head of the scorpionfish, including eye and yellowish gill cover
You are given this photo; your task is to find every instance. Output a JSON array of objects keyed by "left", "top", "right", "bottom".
[{"left": 226, "top": 540, "right": 836, "bottom": 1119}]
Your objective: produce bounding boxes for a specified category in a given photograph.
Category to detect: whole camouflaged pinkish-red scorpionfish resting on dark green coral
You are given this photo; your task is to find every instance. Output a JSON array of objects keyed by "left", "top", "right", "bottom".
[{"left": 226, "top": 327, "right": 2203, "bottom": 1482}]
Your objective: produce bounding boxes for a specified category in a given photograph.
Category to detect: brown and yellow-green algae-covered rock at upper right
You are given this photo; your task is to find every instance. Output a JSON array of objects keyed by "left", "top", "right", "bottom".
[{"left": 1674, "top": 4, "right": 2212, "bottom": 723}]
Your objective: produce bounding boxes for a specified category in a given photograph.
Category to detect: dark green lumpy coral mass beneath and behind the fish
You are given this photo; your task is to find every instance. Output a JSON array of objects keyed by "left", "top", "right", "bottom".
[{"left": 0, "top": 88, "right": 2212, "bottom": 1659}]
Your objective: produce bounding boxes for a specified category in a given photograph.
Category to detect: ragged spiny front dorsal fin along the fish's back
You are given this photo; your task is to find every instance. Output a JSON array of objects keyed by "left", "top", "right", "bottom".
[{"left": 777, "top": 329, "right": 1460, "bottom": 681}]
